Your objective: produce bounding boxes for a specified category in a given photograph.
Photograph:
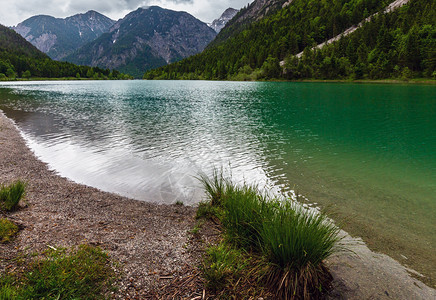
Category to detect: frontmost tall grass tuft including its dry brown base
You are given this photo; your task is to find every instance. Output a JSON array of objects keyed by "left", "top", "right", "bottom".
[{"left": 261, "top": 201, "right": 340, "bottom": 299}]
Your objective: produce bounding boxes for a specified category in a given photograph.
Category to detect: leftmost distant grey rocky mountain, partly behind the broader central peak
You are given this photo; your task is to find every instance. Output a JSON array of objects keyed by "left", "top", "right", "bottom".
[{"left": 12, "top": 10, "right": 115, "bottom": 60}]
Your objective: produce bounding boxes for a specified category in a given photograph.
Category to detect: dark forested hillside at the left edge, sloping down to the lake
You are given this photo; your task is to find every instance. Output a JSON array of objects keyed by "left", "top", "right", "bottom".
[{"left": 0, "top": 25, "right": 131, "bottom": 80}]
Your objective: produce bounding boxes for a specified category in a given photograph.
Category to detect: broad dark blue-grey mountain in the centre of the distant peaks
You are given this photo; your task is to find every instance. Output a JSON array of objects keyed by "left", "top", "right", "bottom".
[{"left": 65, "top": 6, "right": 216, "bottom": 77}]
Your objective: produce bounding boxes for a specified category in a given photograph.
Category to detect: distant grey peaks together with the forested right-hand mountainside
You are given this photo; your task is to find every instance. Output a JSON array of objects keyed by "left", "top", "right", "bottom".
[{"left": 7, "top": 0, "right": 436, "bottom": 80}]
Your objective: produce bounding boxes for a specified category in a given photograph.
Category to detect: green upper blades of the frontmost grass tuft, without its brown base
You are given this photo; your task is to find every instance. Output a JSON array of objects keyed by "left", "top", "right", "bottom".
[{"left": 261, "top": 201, "right": 340, "bottom": 269}]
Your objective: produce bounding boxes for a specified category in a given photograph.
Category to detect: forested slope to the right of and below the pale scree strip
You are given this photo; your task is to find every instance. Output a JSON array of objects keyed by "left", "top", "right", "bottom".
[{"left": 283, "top": 0, "right": 436, "bottom": 80}]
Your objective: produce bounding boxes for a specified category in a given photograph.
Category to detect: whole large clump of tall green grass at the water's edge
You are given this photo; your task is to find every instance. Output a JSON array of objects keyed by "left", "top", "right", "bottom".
[{"left": 197, "top": 170, "right": 342, "bottom": 299}]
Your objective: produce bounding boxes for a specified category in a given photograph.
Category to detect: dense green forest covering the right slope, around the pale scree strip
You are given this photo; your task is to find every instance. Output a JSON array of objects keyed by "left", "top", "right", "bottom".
[{"left": 144, "top": 0, "right": 436, "bottom": 80}]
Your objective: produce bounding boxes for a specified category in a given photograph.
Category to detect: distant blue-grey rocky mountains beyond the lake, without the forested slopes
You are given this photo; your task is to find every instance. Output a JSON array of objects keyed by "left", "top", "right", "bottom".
[{"left": 12, "top": 6, "right": 237, "bottom": 77}]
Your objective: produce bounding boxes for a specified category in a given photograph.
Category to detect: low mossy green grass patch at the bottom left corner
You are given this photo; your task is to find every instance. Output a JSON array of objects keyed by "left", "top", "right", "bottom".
[{"left": 0, "top": 245, "right": 114, "bottom": 299}]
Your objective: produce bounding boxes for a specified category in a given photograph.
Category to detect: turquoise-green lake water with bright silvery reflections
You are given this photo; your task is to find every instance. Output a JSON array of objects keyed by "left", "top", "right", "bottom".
[{"left": 0, "top": 81, "right": 436, "bottom": 284}]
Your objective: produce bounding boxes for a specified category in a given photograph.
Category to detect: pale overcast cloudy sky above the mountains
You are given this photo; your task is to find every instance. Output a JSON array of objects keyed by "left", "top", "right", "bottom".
[{"left": 0, "top": 0, "right": 253, "bottom": 26}]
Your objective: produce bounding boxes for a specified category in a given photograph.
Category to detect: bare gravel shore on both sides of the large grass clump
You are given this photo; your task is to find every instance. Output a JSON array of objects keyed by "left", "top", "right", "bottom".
[{"left": 0, "top": 111, "right": 436, "bottom": 299}]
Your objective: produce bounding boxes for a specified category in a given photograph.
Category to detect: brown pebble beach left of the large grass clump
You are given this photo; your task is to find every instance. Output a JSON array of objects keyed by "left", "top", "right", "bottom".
[{"left": 0, "top": 113, "right": 196, "bottom": 299}]
